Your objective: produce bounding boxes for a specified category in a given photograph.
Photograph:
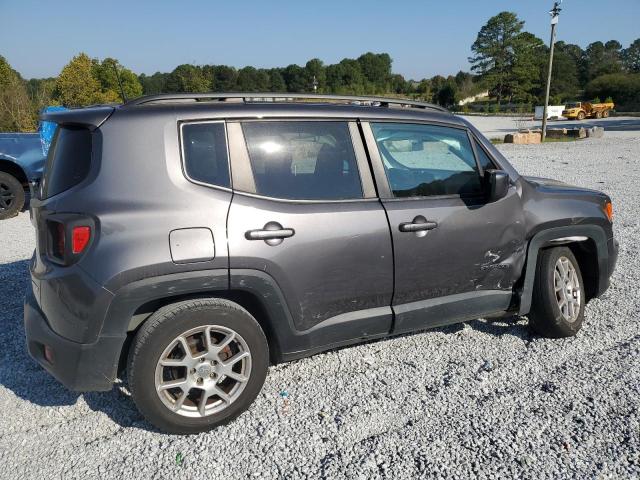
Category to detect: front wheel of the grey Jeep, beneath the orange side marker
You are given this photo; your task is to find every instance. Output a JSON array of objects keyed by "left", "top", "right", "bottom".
[{"left": 529, "top": 247, "right": 585, "bottom": 338}]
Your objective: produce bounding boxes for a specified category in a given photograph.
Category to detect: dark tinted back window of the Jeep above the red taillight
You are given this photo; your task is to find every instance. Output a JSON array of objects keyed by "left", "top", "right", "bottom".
[{"left": 42, "top": 126, "right": 91, "bottom": 198}]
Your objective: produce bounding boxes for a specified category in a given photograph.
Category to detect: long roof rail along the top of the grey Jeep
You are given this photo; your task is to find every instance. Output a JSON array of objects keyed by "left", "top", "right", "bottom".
[{"left": 123, "top": 92, "right": 449, "bottom": 112}]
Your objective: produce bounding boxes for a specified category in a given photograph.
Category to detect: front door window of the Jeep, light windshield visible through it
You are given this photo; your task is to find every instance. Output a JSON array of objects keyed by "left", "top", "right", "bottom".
[{"left": 371, "top": 123, "right": 482, "bottom": 197}]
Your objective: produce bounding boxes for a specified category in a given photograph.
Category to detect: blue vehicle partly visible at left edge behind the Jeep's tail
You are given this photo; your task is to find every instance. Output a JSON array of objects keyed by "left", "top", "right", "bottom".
[{"left": 0, "top": 133, "right": 45, "bottom": 220}]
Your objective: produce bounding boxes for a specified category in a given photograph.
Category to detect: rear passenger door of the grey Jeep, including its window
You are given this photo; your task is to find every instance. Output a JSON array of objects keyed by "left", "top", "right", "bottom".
[{"left": 227, "top": 120, "right": 393, "bottom": 346}]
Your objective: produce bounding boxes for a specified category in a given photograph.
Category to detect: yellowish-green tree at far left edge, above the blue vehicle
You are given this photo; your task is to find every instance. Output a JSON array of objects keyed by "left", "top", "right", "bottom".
[{"left": 0, "top": 55, "right": 36, "bottom": 132}]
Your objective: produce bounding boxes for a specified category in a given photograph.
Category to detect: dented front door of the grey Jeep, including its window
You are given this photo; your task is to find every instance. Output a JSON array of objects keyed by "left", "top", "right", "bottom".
[{"left": 363, "top": 122, "right": 524, "bottom": 332}]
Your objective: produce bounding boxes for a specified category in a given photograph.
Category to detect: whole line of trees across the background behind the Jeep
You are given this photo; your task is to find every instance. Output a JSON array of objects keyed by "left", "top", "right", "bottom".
[{"left": 0, "top": 12, "right": 640, "bottom": 131}]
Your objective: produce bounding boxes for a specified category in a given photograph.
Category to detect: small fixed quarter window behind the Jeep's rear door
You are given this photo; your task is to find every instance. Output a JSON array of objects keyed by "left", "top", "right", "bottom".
[{"left": 182, "top": 122, "right": 231, "bottom": 187}]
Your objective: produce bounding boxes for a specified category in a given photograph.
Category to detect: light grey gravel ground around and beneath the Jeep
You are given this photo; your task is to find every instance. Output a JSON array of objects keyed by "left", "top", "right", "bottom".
[{"left": 0, "top": 124, "right": 640, "bottom": 479}]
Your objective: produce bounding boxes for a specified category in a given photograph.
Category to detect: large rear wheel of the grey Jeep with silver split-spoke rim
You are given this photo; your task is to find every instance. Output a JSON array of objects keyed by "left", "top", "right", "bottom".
[{"left": 127, "top": 298, "right": 269, "bottom": 434}]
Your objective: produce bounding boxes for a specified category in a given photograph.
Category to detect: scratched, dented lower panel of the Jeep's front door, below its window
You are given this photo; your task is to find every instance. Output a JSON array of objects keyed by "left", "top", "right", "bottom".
[{"left": 383, "top": 187, "right": 526, "bottom": 305}]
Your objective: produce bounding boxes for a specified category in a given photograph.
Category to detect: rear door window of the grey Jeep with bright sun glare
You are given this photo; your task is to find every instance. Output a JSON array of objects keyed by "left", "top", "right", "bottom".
[{"left": 242, "top": 121, "right": 362, "bottom": 200}]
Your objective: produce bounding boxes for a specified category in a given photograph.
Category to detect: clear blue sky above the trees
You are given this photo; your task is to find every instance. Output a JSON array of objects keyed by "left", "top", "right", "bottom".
[{"left": 0, "top": 0, "right": 640, "bottom": 79}]
